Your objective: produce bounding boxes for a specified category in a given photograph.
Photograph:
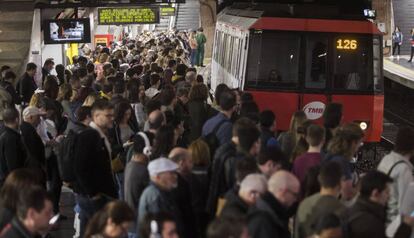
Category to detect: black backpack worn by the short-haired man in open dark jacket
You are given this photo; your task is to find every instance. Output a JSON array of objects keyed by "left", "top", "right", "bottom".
[{"left": 57, "top": 128, "right": 87, "bottom": 183}]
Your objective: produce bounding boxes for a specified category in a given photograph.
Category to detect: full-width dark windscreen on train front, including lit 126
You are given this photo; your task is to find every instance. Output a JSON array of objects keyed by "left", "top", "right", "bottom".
[{"left": 246, "top": 30, "right": 382, "bottom": 93}]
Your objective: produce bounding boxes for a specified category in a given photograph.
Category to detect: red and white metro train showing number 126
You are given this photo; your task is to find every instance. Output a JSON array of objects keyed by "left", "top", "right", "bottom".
[{"left": 210, "top": 3, "right": 384, "bottom": 142}]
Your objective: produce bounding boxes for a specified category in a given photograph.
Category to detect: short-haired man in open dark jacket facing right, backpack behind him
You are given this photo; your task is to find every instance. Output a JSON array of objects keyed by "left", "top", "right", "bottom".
[{"left": 74, "top": 100, "right": 117, "bottom": 236}]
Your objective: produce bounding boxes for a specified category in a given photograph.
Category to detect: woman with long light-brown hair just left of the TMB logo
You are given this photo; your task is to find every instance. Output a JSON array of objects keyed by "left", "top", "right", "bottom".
[{"left": 277, "top": 111, "right": 307, "bottom": 158}]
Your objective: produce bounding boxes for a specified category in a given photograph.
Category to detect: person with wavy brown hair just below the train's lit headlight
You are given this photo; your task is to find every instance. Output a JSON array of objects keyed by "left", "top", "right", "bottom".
[{"left": 324, "top": 123, "right": 364, "bottom": 201}]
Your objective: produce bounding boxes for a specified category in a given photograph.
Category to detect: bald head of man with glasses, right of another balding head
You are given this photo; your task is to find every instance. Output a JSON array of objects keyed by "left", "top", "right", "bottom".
[{"left": 267, "top": 170, "right": 300, "bottom": 207}]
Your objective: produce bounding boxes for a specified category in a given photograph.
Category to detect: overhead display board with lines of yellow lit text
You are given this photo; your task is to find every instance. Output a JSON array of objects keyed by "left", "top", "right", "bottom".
[{"left": 98, "top": 7, "right": 160, "bottom": 25}]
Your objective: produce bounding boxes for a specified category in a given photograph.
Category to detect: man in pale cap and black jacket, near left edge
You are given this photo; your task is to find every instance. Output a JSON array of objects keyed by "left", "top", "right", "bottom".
[{"left": 20, "top": 107, "right": 46, "bottom": 179}]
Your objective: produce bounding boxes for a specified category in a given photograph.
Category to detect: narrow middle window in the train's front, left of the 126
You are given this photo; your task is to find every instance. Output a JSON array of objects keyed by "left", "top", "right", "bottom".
[{"left": 305, "top": 36, "right": 328, "bottom": 89}]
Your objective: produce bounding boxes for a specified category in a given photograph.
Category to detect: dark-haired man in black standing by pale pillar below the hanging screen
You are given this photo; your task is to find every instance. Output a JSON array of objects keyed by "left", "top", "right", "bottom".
[{"left": 17, "top": 63, "right": 37, "bottom": 104}]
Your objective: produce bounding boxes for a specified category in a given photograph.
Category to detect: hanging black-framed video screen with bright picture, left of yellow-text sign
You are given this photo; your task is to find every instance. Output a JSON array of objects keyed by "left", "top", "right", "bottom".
[{"left": 43, "top": 18, "right": 91, "bottom": 44}]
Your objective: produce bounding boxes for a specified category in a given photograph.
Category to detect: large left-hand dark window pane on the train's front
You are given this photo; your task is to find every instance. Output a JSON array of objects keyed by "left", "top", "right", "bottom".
[{"left": 247, "top": 32, "right": 300, "bottom": 88}]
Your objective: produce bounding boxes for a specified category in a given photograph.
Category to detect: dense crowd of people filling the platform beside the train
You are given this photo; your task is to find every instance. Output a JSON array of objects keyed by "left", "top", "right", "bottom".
[{"left": 0, "top": 29, "right": 414, "bottom": 238}]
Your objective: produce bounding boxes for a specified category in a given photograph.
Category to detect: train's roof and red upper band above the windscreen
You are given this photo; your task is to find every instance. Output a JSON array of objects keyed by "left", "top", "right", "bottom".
[{"left": 217, "top": 3, "right": 382, "bottom": 35}]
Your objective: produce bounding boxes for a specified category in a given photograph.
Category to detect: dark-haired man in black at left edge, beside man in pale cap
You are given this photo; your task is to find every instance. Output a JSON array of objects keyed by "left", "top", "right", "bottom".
[{"left": 0, "top": 108, "right": 26, "bottom": 187}]
